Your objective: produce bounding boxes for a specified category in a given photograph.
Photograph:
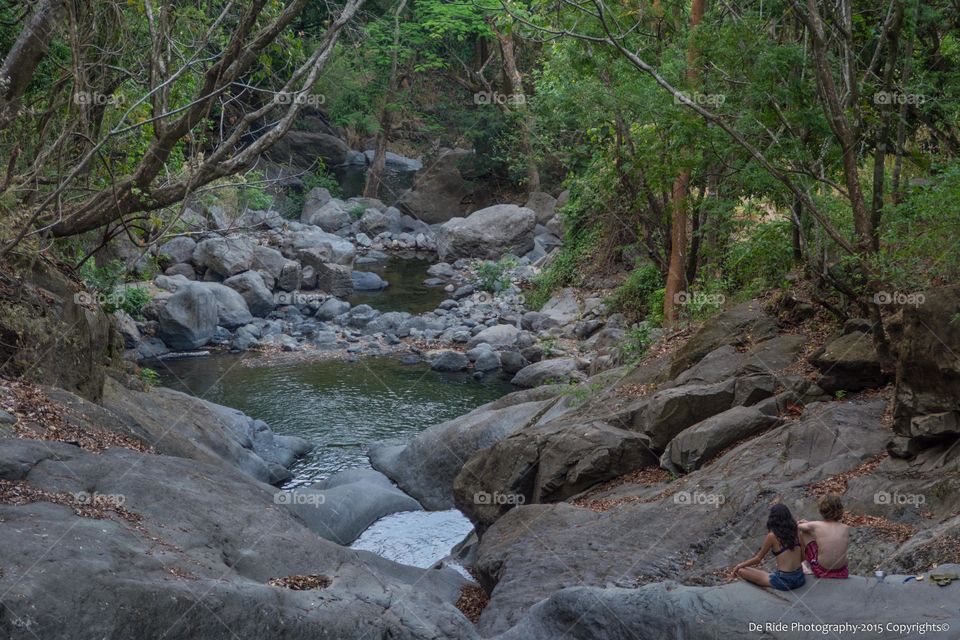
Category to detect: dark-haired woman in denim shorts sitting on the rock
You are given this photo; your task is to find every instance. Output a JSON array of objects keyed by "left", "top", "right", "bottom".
[{"left": 733, "top": 504, "right": 806, "bottom": 591}]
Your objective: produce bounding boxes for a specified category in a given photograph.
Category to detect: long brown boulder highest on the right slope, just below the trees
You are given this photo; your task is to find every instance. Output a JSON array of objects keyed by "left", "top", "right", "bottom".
[{"left": 670, "top": 301, "right": 777, "bottom": 378}]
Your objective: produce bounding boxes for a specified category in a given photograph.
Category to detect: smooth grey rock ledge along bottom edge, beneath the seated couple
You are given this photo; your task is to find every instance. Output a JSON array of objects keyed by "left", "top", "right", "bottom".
[{"left": 496, "top": 565, "right": 960, "bottom": 640}]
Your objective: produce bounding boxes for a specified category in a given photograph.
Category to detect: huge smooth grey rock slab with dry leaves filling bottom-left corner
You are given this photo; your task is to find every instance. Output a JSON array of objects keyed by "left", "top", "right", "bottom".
[{"left": 0, "top": 436, "right": 477, "bottom": 640}]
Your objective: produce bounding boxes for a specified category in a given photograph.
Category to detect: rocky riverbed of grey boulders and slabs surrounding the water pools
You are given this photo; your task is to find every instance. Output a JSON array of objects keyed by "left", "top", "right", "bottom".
[{"left": 0, "top": 172, "right": 960, "bottom": 640}]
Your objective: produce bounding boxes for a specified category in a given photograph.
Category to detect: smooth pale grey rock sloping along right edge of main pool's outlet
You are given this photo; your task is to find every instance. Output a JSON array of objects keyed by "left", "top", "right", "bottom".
[{"left": 370, "top": 400, "right": 554, "bottom": 509}]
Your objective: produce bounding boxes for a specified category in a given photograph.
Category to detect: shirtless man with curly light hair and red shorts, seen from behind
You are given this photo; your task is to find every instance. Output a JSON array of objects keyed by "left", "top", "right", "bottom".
[{"left": 797, "top": 493, "right": 850, "bottom": 578}]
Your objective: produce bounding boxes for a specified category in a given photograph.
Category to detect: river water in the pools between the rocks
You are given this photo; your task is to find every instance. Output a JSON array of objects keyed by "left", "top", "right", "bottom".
[{"left": 153, "top": 260, "right": 513, "bottom": 567}]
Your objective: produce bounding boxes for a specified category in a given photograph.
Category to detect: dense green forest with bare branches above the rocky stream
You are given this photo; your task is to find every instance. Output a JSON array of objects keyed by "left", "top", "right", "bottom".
[{"left": 0, "top": 0, "right": 960, "bottom": 344}]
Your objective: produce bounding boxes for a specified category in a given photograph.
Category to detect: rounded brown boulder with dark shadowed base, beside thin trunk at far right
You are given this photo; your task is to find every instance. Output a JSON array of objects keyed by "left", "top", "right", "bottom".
[{"left": 810, "top": 331, "right": 887, "bottom": 393}]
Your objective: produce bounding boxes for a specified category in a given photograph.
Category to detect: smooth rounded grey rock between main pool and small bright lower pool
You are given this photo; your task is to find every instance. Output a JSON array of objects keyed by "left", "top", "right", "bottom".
[{"left": 281, "top": 469, "right": 422, "bottom": 545}]
